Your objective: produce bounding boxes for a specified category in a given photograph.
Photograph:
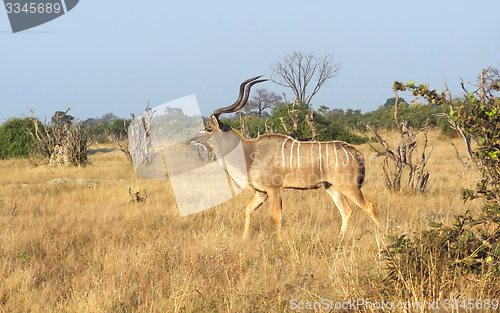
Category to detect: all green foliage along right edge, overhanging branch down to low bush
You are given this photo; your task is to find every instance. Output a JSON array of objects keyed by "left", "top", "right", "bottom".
[{"left": 384, "top": 70, "right": 500, "bottom": 298}]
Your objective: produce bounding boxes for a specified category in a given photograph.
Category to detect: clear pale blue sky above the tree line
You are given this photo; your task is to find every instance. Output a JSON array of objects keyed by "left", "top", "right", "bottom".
[{"left": 0, "top": 0, "right": 500, "bottom": 123}]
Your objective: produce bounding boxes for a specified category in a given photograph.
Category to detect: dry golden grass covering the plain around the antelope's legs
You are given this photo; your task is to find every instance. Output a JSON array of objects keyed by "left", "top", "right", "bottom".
[{"left": 0, "top": 132, "right": 484, "bottom": 312}]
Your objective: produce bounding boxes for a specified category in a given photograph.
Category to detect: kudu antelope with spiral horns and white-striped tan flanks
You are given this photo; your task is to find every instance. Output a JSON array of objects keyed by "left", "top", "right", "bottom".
[{"left": 192, "top": 76, "right": 380, "bottom": 240}]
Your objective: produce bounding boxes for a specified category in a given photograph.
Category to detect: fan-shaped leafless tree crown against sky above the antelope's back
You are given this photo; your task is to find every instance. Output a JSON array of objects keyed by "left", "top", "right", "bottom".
[{"left": 271, "top": 51, "right": 342, "bottom": 105}]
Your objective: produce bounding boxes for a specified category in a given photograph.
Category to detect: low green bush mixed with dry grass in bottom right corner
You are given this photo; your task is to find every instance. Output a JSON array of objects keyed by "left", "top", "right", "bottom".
[{"left": 384, "top": 206, "right": 500, "bottom": 299}]
